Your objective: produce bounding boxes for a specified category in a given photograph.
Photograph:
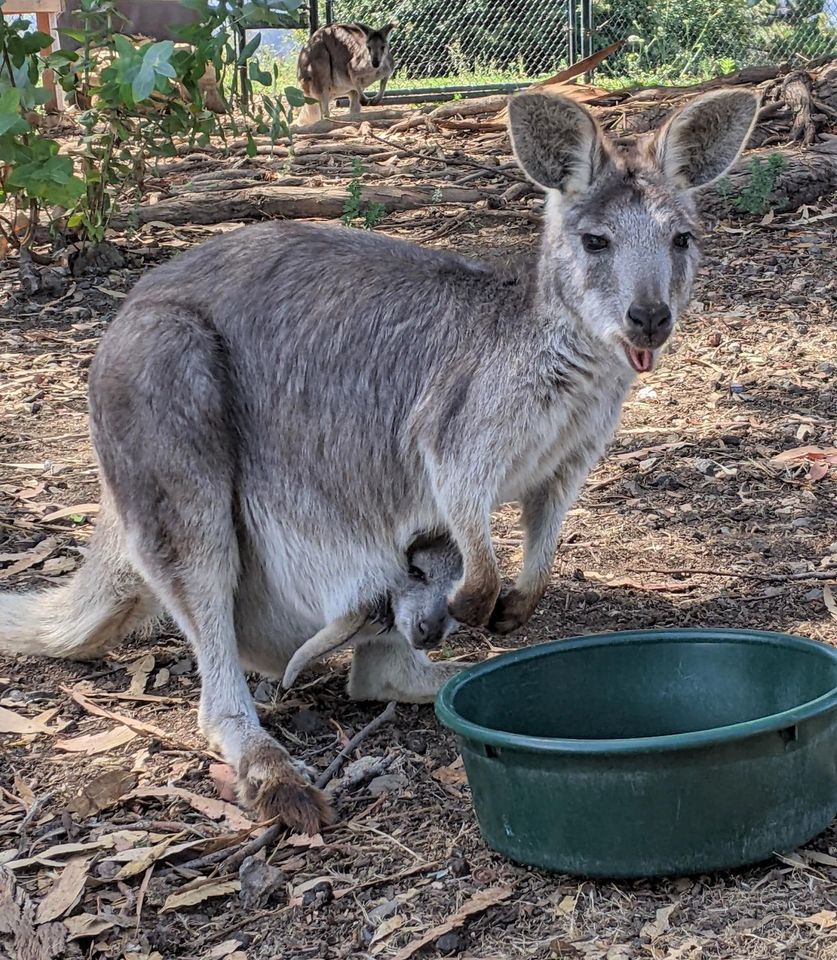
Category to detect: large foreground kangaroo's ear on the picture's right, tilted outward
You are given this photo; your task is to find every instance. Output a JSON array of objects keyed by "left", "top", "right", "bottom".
[{"left": 654, "top": 90, "right": 759, "bottom": 190}]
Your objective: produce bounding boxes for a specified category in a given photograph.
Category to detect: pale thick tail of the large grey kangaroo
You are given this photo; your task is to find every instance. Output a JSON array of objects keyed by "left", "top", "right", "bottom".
[{"left": 0, "top": 499, "right": 158, "bottom": 660}]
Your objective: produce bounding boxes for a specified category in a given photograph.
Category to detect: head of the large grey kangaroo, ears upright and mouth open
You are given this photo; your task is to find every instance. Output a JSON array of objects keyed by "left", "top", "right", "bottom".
[{"left": 509, "top": 90, "right": 759, "bottom": 372}]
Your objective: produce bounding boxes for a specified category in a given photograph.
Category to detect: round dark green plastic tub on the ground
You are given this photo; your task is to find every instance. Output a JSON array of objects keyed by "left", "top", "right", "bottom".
[{"left": 436, "top": 630, "right": 837, "bottom": 877}]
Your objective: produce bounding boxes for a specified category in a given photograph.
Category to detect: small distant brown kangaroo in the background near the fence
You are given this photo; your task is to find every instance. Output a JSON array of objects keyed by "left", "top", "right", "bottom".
[{"left": 297, "top": 23, "right": 395, "bottom": 124}]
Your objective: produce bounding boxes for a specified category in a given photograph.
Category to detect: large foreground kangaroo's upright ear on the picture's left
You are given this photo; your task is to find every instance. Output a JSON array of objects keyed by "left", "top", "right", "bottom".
[{"left": 509, "top": 93, "right": 608, "bottom": 196}]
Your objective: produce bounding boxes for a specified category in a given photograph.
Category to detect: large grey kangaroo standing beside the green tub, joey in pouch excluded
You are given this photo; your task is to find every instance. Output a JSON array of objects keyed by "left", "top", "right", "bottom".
[{"left": 0, "top": 90, "right": 758, "bottom": 831}]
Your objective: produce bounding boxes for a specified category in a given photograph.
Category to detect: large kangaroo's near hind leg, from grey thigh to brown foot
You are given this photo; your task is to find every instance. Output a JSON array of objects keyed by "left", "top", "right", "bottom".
[{"left": 91, "top": 305, "right": 330, "bottom": 832}]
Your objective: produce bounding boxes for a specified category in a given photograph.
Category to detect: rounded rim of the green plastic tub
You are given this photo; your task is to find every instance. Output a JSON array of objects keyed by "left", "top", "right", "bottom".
[{"left": 436, "top": 628, "right": 837, "bottom": 756}]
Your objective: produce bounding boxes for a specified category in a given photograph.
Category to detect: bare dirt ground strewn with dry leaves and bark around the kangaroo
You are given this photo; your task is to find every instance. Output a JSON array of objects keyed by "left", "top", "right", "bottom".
[{"left": 0, "top": 129, "right": 837, "bottom": 960}]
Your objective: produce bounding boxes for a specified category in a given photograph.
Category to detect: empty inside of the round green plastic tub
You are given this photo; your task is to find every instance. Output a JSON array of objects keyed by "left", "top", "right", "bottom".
[{"left": 453, "top": 640, "right": 837, "bottom": 740}]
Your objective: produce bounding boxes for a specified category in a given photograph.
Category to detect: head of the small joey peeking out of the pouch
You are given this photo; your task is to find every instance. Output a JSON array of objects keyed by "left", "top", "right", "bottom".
[{"left": 392, "top": 534, "right": 462, "bottom": 649}]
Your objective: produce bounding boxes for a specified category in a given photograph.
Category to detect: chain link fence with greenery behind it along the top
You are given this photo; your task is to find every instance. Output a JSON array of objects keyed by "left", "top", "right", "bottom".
[{"left": 320, "top": 0, "right": 837, "bottom": 99}]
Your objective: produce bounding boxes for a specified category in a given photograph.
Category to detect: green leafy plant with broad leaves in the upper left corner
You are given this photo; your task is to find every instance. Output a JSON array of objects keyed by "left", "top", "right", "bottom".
[{"left": 0, "top": 0, "right": 304, "bottom": 253}]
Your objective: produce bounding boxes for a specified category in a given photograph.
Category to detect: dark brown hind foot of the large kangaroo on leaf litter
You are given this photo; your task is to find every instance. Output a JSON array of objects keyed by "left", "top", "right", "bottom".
[{"left": 237, "top": 743, "right": 334, "bottom": 834}]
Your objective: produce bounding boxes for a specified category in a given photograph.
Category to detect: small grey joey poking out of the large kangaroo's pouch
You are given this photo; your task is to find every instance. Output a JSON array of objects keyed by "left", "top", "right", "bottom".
[{"left": 282, "top": 534, "right": 462, "bottom": 699}]
